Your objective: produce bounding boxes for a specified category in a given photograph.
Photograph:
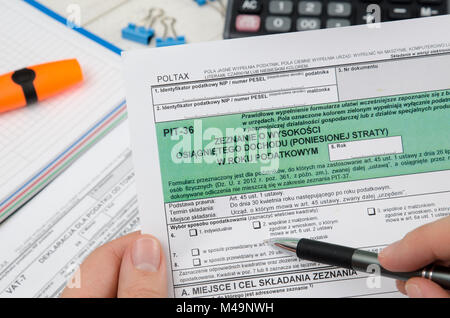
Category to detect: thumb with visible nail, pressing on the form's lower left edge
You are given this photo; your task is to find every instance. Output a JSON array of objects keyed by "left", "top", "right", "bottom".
[{"left": 117, "top": 235, "right": 167, "bottom": 298}]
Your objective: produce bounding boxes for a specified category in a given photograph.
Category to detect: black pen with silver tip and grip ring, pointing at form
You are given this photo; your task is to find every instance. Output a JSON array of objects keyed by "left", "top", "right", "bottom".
[{"left": 268, "top": 238, "right": 450, "bottom": 289}]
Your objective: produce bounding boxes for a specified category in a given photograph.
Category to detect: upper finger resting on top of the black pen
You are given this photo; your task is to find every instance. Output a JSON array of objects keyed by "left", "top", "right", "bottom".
[{"left": 378, "top": 217, "right": 450, "bottom": 271}]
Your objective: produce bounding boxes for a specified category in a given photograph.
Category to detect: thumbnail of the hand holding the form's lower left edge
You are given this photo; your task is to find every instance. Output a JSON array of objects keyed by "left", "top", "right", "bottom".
[{"left": 131, "top": 238, "right": 161, "bottom": 272}]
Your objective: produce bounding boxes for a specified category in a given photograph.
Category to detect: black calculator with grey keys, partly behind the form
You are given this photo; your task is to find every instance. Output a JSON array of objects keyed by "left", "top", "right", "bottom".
[{"left": 224, "top": 0, "right": 450, "bottom": 39}]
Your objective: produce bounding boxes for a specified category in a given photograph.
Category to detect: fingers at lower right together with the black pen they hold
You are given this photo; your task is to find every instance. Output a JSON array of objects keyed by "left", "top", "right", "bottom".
[{"left": 269, "top": 216, "right": 450, "bottom": 297}]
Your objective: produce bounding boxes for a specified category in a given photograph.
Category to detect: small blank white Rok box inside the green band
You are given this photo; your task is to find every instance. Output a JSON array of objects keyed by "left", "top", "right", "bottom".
[{"left": 328, "top": 136, "right": 403, "bottom": 161}]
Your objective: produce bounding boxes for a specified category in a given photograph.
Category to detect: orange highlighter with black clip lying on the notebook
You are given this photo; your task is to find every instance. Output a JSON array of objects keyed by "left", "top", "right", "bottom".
[{"left": 0, "top": 59, "right": 83, "bottom": 113}]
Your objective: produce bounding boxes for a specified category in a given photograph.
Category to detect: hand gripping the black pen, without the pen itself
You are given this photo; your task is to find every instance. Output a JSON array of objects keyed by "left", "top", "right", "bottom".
[{"left": 378, "top": 216, "right": 450, "bottom": 298}]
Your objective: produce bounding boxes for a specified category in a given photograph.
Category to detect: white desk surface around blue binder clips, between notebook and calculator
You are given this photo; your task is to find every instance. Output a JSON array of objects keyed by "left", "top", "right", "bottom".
[{"left": 40, "top": 0, "right": 226, "bottom": 50}]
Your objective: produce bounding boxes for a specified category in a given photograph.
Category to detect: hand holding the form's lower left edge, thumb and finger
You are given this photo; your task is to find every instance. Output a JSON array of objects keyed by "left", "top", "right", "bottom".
[{"left": 61, "top": 232, "right": 167, "bottom": 298}]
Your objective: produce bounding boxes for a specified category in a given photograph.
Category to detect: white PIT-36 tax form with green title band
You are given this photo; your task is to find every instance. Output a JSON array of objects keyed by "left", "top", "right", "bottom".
[{"left": 123, "top": 16, "right": 450, "bottom": 297}]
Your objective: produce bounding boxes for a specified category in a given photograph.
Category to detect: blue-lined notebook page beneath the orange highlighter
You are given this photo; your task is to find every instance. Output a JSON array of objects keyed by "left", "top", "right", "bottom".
[{"left": 0, "top": 0, "right": 125, "bottom": 204}]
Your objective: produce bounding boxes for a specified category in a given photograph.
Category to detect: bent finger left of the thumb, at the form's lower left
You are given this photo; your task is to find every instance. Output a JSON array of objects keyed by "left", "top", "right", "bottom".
[{"left": 61, "top": 232, "right": 140, "bottom": 298}]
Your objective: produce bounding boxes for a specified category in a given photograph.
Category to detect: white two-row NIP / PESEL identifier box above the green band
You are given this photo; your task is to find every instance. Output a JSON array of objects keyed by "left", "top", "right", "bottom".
[{"left": 151, "top": 67, "right": 339, "bottom": 122}]
